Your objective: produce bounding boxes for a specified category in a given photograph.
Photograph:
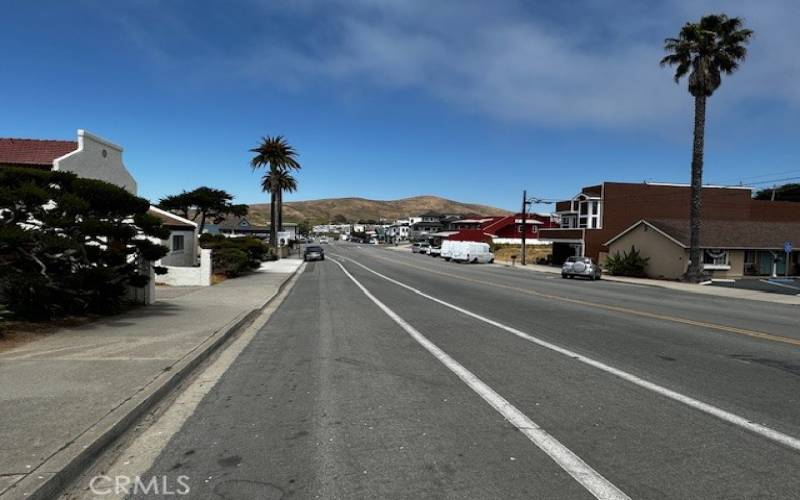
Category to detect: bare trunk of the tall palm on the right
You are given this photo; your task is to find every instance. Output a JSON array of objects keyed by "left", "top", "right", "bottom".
[{"left": 686, "top": 95, "right": 706, "bottom": 283}]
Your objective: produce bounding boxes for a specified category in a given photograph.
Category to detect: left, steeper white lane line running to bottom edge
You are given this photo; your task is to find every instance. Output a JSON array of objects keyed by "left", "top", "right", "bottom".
[{"left": 331, "top": 259, "right": 630, "bottom": 499}]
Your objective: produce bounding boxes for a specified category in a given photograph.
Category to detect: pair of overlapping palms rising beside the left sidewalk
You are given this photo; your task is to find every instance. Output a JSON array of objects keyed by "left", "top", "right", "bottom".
[{"left": 250, "top": 135, "right": 300, "bottom": 248}]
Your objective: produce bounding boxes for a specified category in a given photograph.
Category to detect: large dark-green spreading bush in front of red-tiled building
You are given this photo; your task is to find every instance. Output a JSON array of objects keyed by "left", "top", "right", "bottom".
[{"left": 0, "top": 167, "right": 168, "bottom": 320}]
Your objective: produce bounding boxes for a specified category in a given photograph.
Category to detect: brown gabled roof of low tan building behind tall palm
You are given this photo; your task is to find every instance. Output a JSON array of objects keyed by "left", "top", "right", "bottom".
[{"left": 606, "top": 219, "right": 800, "bottom": 250}]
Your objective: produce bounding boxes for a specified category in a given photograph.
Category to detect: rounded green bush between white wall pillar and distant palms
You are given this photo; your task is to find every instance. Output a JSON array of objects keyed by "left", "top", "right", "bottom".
[{"left": 200, "top": 233, "right": 276, "bottom": 278}]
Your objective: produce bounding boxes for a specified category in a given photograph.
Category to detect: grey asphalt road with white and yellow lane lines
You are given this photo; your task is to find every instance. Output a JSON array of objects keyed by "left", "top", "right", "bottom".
[{"left": 134, "top": 244, "right": 800, "bottom": 499}]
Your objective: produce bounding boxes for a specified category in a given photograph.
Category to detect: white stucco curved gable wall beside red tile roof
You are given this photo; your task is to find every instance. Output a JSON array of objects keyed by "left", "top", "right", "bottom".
[{"left": 53, "top": 130, "right": 137, "bottom": 194}]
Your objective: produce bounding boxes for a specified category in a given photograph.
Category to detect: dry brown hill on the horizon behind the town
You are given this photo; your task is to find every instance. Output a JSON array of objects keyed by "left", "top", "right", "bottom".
[{"left": 249, "top": 196, "right": 511, "bottom": 223}]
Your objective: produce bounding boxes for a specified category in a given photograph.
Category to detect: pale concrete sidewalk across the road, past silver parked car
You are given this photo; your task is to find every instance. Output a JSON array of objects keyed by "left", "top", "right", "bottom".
[{"left": 493, "top": 262, "right": 800, "bottom": 305}]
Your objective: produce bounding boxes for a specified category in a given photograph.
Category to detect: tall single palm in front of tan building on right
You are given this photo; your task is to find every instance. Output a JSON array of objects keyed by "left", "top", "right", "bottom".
[{"left": 661, "top": 14, "right": 753, "bottom": 283}]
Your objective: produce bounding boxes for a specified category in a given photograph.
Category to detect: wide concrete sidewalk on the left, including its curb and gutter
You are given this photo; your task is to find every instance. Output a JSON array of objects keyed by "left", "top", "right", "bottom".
[{"left": 0, "top": 259, "right": 302, "bottom": 500}]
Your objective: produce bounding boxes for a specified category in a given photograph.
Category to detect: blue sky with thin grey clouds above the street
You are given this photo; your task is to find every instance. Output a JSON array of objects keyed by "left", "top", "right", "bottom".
[{"left": 0, "top": 0, "right": 800, "bottom": 209}]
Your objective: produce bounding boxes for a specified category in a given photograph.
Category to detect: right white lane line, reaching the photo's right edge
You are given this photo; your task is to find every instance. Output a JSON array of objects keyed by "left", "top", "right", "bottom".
[{"left": 332, "top": 257, "right": 800, "bottom": 451}]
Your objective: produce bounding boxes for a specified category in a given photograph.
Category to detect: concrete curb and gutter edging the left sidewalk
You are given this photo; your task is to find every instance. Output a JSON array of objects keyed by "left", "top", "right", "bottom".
[{"left": 0, "top": 265, "right": 303, "bottom": 500}]
